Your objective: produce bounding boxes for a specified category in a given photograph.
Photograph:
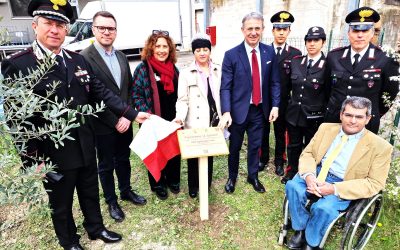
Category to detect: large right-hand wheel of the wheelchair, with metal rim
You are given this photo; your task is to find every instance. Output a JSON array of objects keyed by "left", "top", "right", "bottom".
[{"left": 342, "top": 193, "right": 383, "bottom": 250}]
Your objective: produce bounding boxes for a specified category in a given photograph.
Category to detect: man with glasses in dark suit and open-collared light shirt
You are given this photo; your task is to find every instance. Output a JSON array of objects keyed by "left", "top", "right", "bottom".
[{"left": 81, "top": 11, "right": 146, "bottom": 222}]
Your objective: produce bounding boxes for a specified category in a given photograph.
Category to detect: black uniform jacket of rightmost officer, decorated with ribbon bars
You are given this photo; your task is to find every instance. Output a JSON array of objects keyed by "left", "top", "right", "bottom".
[{"left": 325, "top": 44, "right": 399, "bottom": 126}]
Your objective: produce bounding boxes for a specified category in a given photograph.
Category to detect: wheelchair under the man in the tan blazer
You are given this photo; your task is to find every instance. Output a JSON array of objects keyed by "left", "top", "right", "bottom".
[{"left": 278, "top": 191, "right": 383, "bottom": 250}]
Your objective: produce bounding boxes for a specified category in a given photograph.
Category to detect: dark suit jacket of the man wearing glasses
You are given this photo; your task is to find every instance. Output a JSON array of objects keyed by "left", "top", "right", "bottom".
[{"left": 80, "top": 44, "right": 133, "bottom": 134}]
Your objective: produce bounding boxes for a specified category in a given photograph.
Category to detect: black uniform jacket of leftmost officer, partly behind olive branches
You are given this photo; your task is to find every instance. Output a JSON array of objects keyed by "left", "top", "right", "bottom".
[{"left": 1, "top": 42, "right": 137, "bottom": 170}]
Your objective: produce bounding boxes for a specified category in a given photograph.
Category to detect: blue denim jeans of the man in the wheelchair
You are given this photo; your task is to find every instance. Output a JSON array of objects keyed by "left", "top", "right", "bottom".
[{"left": 285, "top": 169, "right": 350, "bottom": 247}]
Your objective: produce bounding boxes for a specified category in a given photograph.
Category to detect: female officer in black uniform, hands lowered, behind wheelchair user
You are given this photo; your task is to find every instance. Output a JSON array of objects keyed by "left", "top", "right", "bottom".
[{"left": 281, "top": 26, "right": 328, "bottom": 183}]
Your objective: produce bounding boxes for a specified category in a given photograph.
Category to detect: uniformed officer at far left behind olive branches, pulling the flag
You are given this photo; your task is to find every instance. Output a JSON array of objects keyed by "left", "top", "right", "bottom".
[{"left": 1, "top": 0, "right": 150, "bottom": 249}]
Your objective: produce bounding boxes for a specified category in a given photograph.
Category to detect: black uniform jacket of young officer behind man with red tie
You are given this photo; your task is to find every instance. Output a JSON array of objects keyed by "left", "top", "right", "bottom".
[{"left": 271, "top": 43, "right": 301, "bottom": 116}]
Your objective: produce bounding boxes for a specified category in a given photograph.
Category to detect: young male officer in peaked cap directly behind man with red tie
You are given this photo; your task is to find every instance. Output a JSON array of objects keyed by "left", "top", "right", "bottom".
[{"left": 259, "top": 11, "right": 301, "bottom": 176}]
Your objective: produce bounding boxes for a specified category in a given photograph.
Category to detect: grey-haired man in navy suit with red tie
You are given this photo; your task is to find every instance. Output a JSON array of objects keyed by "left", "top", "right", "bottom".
[{"left": 220, "top": 12, "right": 280, "bottom": 193}]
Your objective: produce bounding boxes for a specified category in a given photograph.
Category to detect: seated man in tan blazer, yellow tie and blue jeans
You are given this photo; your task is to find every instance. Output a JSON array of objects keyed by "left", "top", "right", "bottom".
[{"left": 285, "top": 97, "right": 392, "bottom": 249}]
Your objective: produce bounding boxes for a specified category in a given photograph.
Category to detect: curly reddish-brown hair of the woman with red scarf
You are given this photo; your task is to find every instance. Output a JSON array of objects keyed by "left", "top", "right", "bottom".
[{"left": 141, "top": 32, "right": 176, "bottom": 64}]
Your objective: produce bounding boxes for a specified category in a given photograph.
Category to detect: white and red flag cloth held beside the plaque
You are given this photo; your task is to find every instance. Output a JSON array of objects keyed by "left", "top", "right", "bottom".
[{"left": 129, "top": 115, "right": 180, "bottom": 181}]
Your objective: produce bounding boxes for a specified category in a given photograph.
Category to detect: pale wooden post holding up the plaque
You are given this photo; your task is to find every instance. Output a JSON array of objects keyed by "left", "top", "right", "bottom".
[{"left": 199, "top": 157, "right": 208, "bottom": 220}]
